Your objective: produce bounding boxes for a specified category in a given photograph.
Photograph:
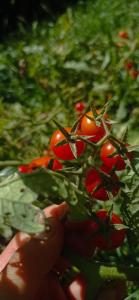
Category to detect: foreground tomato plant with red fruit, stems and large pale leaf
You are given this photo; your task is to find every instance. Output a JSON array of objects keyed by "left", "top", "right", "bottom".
[{"left": 0, "top": 101, "right": 139, "bottom": 300}]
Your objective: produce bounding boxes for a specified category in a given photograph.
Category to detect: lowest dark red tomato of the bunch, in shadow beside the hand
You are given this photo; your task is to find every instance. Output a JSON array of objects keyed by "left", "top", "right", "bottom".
[{"left": 93, "top": 210, "right": 126, "bottom": 250}]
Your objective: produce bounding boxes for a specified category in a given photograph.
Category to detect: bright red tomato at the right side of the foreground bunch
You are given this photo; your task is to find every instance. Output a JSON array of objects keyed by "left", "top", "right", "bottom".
[{"left": 100, "top": 141, "right": 125, "bottom": 171}]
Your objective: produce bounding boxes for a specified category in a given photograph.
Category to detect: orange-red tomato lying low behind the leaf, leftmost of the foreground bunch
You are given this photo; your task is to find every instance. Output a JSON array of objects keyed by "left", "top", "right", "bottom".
[{"left": 29, "top": 156, "right": 62, "bottom": 171}]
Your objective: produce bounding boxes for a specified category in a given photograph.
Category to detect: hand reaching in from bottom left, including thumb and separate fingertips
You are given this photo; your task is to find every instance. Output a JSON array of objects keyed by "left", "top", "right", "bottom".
[{"left": 0, "top": 202, "right": 125, "bottom": 300}]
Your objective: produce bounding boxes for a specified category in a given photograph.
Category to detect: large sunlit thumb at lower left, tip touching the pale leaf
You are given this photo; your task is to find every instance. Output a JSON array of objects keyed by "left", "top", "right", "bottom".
[{"left": 0, "top": 202, "right": 68, "bottom": 300}]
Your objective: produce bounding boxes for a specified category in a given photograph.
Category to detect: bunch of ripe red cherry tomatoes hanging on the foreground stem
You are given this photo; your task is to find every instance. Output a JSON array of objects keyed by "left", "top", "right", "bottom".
[{"left": 18, "top": 103, "right": 131, "bottom": 257}]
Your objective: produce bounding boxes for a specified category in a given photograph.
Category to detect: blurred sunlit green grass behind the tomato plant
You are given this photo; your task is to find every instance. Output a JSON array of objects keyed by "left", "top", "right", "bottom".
[{"left": 0, "top": 0, "right": 139, "bottom": 161}]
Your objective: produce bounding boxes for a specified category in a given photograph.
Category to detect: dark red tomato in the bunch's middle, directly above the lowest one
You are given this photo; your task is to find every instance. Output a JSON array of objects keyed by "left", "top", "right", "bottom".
[{"left": 85, "top": 165, "right": 119, "bottom": 201}]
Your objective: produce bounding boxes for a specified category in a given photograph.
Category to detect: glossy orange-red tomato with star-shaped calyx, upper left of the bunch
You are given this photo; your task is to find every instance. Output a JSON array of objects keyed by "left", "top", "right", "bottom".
[{"left": 50, "top": 127, "right": 86, "bottom": 160}]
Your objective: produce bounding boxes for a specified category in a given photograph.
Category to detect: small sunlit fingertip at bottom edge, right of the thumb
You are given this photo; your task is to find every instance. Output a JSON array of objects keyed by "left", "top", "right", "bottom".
[{"left": 65, "top": 274, "right": 87, "bottom": 300}]
